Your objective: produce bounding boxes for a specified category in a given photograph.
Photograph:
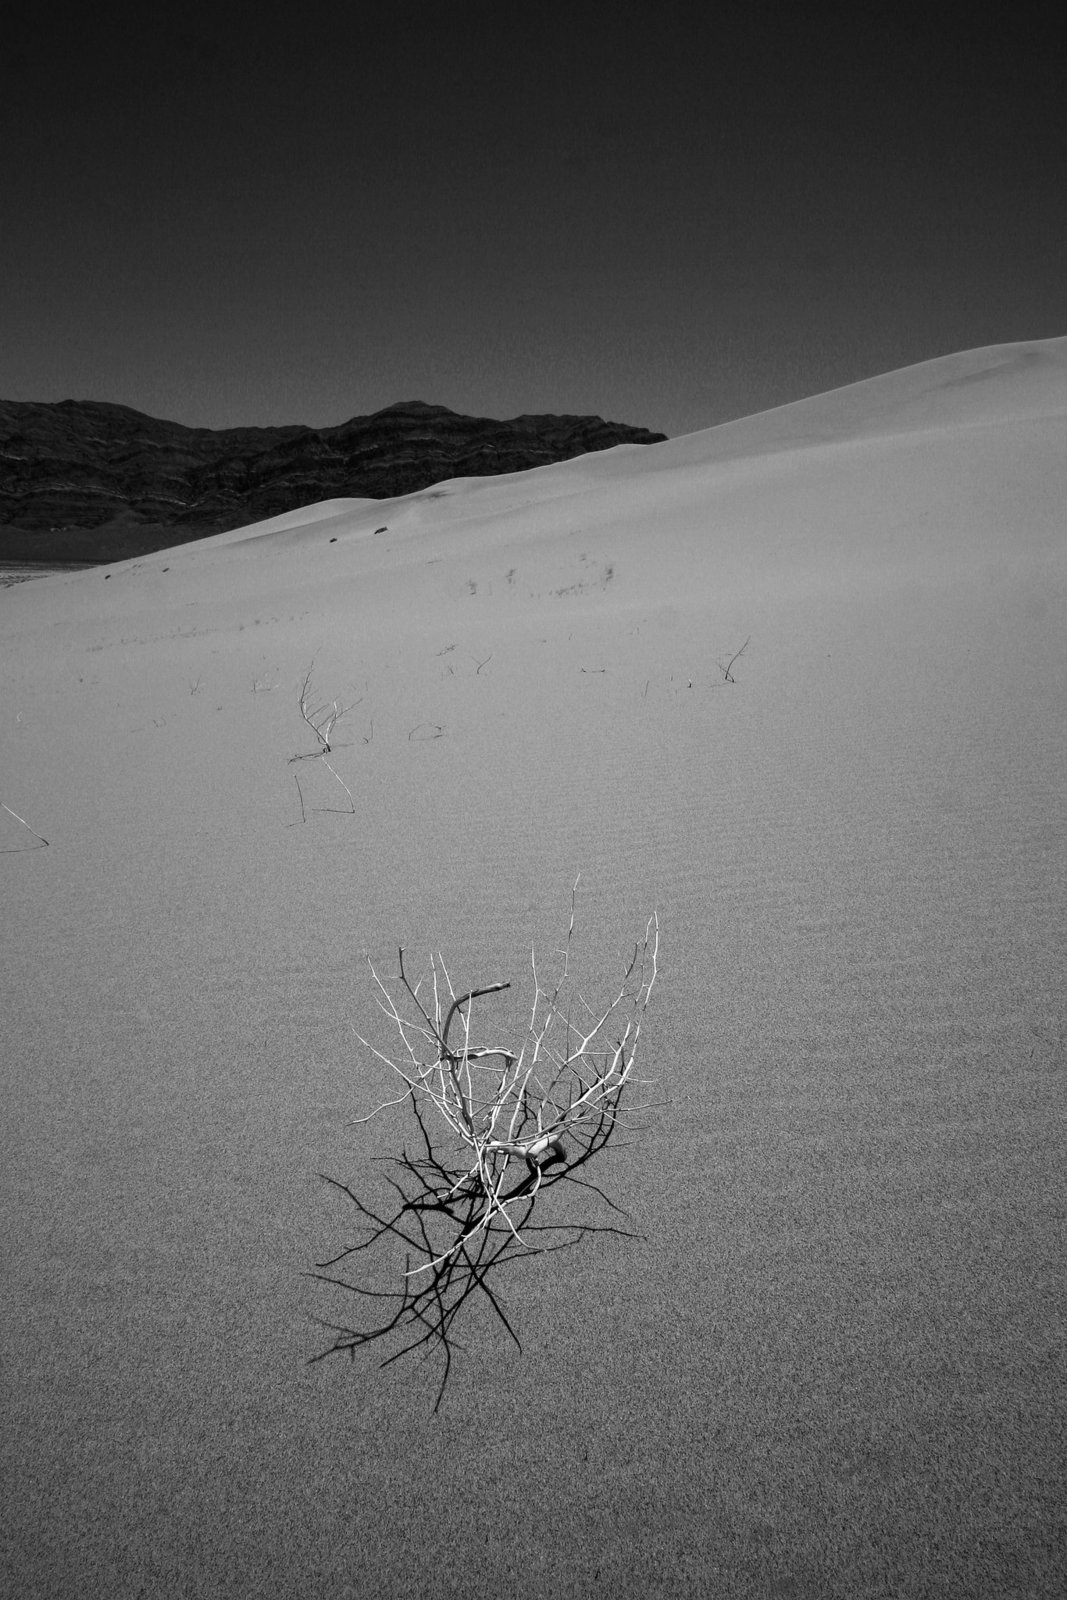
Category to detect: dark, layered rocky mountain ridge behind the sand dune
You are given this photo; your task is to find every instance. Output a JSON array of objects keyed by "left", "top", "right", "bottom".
[{"left": 0, "top": 400, "right": 664, "bottom": 562}]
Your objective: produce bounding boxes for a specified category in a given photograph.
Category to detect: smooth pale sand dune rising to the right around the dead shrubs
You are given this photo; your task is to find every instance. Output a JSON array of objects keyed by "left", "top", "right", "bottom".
[{"left": 0, "top": 339, "right": 1067, "bottom": 1600}]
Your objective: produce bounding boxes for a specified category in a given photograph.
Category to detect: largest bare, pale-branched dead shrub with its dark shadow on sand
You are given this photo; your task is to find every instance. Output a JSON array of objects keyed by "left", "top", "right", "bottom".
[{"left": 315, "top": 883, "right": 659, "bottom": 1403}]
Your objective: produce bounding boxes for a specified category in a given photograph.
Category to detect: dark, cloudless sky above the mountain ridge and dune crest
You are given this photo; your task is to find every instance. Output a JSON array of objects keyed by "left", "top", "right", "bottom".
[{"left": 0, "top": 0, "right": 1067, "bottom": 434}]
